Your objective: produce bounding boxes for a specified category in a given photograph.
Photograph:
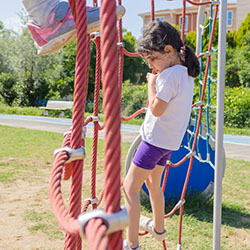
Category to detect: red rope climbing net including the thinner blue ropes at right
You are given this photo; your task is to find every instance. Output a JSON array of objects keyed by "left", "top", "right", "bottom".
[{"left": 50, "top": 0, "right": 219, "bottom": 250}]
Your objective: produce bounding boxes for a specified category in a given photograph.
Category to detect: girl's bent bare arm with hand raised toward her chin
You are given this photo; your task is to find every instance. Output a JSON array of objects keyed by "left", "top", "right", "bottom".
[{"left": 147, "top": 73, "right": 167, "bottom": 117}]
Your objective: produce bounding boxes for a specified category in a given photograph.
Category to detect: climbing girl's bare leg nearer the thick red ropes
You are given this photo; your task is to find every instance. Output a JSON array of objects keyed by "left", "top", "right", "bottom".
[{"left": 123, "top": 163, "right": 153, "bottom": 248}]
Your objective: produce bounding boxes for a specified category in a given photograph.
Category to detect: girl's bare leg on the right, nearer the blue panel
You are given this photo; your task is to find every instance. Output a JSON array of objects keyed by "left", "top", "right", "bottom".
[{"left": 146, "top": 165, "right": 165, "bottom": 233}]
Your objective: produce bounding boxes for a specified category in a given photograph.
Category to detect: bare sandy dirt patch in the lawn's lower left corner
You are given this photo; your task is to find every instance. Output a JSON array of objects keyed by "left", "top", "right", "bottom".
[{"left": 0, "top": 180, "right": 64, "bottom": 250}]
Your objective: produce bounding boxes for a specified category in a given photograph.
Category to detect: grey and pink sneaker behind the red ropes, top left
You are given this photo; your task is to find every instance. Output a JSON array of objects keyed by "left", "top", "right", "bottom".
[{"left": 27, "top": 1, "right": 125, "bottom": 55}]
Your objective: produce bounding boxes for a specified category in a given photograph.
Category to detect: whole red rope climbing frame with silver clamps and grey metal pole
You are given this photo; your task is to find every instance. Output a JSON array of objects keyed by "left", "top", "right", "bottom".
[{"left": 50, "top": 0, "right": 226, "bottom": 250}]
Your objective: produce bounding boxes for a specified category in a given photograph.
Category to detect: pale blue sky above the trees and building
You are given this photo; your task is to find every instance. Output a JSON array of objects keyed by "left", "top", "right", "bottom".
[{"left": 0, "top": 0, "right": 236, "bottom": 39}]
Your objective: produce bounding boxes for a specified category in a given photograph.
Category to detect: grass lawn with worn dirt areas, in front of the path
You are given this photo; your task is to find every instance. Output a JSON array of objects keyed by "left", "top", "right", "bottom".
[{"left": 0, "top": 126, "right": 250, "bottom": 250}]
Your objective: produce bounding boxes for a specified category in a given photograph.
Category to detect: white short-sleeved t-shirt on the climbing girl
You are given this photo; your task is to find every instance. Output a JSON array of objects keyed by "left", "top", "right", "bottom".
[{"left": 140, "top": 65, "right": 194, "bottom": 150}]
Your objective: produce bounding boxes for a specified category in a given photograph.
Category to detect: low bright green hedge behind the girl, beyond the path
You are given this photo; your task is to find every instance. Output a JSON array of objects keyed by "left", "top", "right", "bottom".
[{"left": 122, "top": 81, "right": 250, "bottom": 128}]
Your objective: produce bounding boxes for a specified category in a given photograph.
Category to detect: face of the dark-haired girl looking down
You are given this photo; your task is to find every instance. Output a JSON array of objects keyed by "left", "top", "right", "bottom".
[{"left": 143, "top": 45, "right": 181, "bottom": 73}]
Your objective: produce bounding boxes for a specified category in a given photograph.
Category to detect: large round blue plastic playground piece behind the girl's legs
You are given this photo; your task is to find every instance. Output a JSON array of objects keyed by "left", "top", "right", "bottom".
[{"left": 125, "top": 120, "right": 225, "bottom": 203}]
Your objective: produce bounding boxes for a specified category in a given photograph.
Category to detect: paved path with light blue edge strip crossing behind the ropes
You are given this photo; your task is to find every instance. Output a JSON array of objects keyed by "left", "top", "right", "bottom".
[{"left": 0, "top": 114, "right": 250, "bottom": 162}]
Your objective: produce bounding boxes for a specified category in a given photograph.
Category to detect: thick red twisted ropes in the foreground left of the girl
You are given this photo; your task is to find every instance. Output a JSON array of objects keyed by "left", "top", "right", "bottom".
[{"left": 50, "top": 0, "right": 122, "bottom": 249}]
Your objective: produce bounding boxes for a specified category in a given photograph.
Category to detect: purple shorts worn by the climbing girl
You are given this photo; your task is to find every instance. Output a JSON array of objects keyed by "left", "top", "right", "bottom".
[{"left": 132, "top": 141, "right": 172, "bottom": 170}]
